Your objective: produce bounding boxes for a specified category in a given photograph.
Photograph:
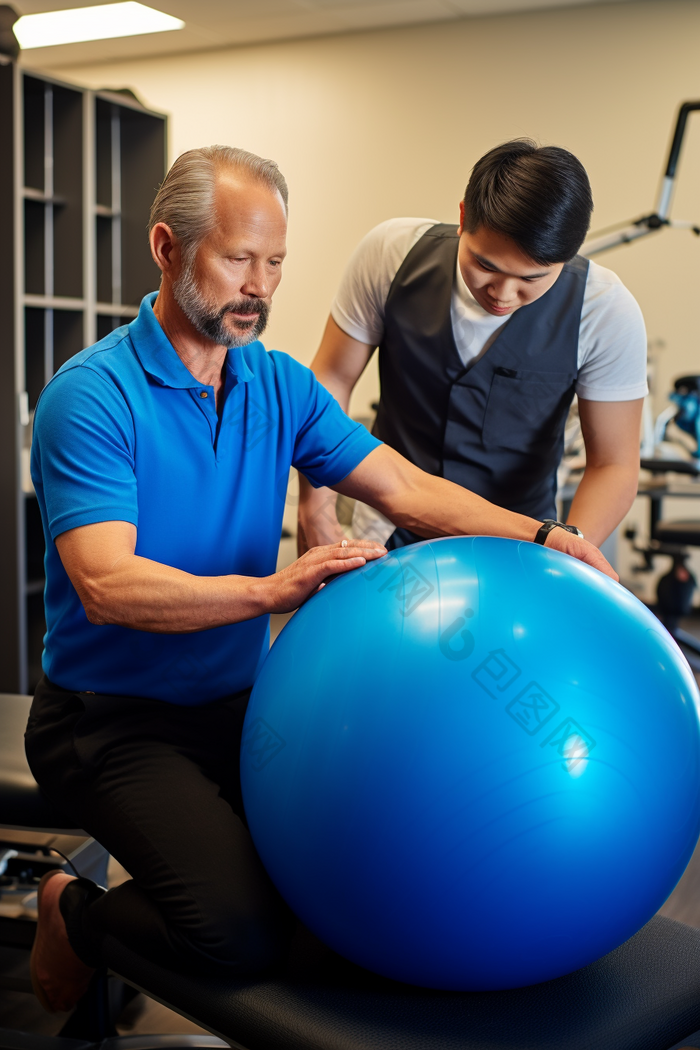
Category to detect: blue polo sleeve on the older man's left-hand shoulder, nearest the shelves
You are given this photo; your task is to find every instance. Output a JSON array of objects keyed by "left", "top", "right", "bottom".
[{"left": 31, "top": 365, "right": 139, "bottom": 540}]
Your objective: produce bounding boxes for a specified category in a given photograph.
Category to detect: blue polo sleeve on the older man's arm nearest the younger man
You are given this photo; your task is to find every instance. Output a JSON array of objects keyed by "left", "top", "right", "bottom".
[{"left": 271, "top": 351, "right": 382, "bottom": 488}]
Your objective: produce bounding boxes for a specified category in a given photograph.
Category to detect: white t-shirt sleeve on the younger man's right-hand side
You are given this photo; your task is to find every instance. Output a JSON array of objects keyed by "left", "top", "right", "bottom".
[{"left": 576, "top": 261, "right": 649, "bottom": 401}]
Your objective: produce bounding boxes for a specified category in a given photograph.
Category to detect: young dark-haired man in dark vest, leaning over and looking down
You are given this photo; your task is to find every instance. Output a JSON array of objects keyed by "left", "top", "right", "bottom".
[{"left": 299, "top": 140, "right": 646, "bottom": 550}]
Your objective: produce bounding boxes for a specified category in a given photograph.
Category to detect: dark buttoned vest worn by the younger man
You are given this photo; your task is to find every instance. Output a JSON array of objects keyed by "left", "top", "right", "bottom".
[{"left": 374, "top": 224, "right": 589, "bottom": 519}]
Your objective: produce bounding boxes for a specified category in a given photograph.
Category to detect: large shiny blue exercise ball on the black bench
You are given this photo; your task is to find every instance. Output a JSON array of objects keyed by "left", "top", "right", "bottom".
[{"left": 241, "top": 537, "right": 700, "bottom": 990}]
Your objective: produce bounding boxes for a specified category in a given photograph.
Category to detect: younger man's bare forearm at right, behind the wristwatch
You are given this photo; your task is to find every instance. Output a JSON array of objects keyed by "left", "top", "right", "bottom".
[{"left": 569, "top": 463, "right": 639, "bottom": 547}]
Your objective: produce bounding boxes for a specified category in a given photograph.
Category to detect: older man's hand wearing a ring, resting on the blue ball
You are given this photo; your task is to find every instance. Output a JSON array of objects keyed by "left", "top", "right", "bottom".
[{"left": 267, "top": 540, "right": 386, "bottom": 612}]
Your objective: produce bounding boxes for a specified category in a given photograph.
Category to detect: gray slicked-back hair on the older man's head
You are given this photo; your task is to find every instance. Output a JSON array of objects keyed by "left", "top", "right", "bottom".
[{"left": 148, "top": 146, "right": 289, "bottom": 265}]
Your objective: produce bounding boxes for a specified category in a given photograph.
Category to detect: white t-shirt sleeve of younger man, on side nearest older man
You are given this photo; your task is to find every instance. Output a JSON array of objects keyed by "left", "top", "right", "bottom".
[{"left": 331, "top": 218, "right": 437, "bottom": 347}]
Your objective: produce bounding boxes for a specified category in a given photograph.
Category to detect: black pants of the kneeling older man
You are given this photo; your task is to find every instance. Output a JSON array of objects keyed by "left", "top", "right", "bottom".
[{"left": 25, "top": 677, "right": 294, "bottom": 974}]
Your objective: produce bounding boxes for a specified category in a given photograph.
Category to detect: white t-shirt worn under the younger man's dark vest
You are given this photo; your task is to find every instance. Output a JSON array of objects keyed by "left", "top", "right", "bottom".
[{"left": 331, "top": 218, "right": 648, "bottom": 543}]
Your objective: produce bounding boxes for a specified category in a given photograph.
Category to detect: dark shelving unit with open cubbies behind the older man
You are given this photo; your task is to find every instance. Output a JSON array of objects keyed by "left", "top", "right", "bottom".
[{"left": 0, "top": 56, "right": 167, "bottom": 693}]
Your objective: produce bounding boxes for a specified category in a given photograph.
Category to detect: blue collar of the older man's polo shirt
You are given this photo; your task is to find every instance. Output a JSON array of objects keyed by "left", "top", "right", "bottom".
[{"left": 129, "top": 292, "right": 255, "bottom": 390}]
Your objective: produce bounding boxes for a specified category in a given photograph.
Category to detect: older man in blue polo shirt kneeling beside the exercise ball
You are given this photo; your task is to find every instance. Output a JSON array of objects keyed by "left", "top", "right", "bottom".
[{"left": 26, "top": 146, "right": 611, "bottom": 1009}]
